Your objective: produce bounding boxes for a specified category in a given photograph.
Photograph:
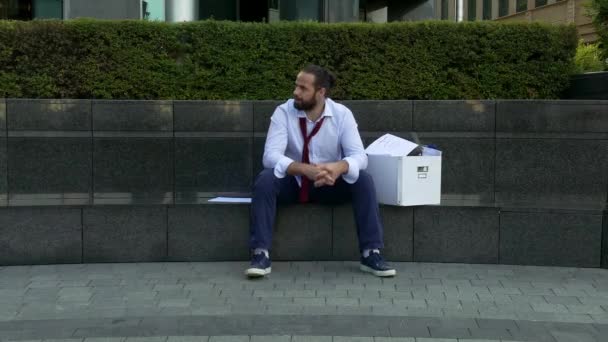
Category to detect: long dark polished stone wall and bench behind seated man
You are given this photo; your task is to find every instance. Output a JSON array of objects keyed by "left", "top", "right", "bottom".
[{"left": 0, "top": 99, "right": 608, "bottom": 267}]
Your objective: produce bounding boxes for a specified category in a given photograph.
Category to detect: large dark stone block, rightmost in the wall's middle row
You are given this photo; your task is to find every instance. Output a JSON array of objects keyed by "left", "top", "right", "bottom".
[{"left": 495, "top": 139, "right": 608, "bottom": 210}]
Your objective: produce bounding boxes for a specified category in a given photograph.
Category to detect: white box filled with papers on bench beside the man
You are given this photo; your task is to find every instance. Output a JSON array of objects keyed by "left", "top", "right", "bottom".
[{"left": 365, "top": 134, "right": 441, "bottom": 206}]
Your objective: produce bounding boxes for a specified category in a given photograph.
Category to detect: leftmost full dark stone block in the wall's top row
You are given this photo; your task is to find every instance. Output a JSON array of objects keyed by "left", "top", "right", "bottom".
[{"left": 7, "top": 99, "right": 91, "bottom": 131}]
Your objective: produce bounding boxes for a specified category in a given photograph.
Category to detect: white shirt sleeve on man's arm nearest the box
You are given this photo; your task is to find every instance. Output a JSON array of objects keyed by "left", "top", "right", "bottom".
[{"left": 341, "top": 111, "right": 367, "bottom": 184}]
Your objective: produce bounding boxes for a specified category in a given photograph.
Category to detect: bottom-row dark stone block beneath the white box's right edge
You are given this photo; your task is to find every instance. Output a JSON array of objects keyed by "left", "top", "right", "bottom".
[{"left": 414, "top": 207, "right": 499, "bottom": 263}]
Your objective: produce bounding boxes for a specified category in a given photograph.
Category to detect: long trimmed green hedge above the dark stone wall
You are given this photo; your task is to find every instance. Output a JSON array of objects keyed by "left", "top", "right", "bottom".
[{"left": 0, "top": 19, "right": 577, "bottom": 100}]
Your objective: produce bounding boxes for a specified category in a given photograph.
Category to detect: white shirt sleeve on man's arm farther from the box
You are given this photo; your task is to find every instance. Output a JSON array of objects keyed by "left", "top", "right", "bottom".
[{"left": 263, "top": 107, "right": 293, "bottom": 178}]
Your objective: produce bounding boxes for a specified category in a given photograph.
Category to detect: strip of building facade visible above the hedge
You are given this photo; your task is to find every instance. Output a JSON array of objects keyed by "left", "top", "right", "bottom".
[{"left": 0, "top": 0, "right": 597, "bottom": 42}]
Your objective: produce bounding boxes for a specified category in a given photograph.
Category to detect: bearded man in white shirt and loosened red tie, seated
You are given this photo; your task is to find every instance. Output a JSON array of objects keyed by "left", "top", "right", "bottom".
[{"left": 245, "top": 65, "right": 396, "bottom": 278}]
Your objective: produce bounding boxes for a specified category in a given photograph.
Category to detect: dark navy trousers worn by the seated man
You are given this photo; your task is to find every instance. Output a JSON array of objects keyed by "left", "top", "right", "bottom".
[{"left": 249, "top": 169, "right": 383, "bottom": 251}]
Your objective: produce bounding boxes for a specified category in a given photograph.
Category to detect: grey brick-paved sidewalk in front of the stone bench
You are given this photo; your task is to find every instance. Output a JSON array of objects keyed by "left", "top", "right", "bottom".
[{"left": 0, "top": 262, "right": 608, "bottom": 342}]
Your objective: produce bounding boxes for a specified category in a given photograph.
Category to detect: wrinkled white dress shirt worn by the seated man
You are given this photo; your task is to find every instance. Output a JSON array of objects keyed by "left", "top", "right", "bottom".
[{"left": 263, "top": 98, "right": 367, "bottom": 184}]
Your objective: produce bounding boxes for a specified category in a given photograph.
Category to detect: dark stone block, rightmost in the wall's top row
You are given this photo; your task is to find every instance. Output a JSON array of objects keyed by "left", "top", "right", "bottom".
[{"left": 496, "top": 100, "right": 608, "bottom": 133}]
